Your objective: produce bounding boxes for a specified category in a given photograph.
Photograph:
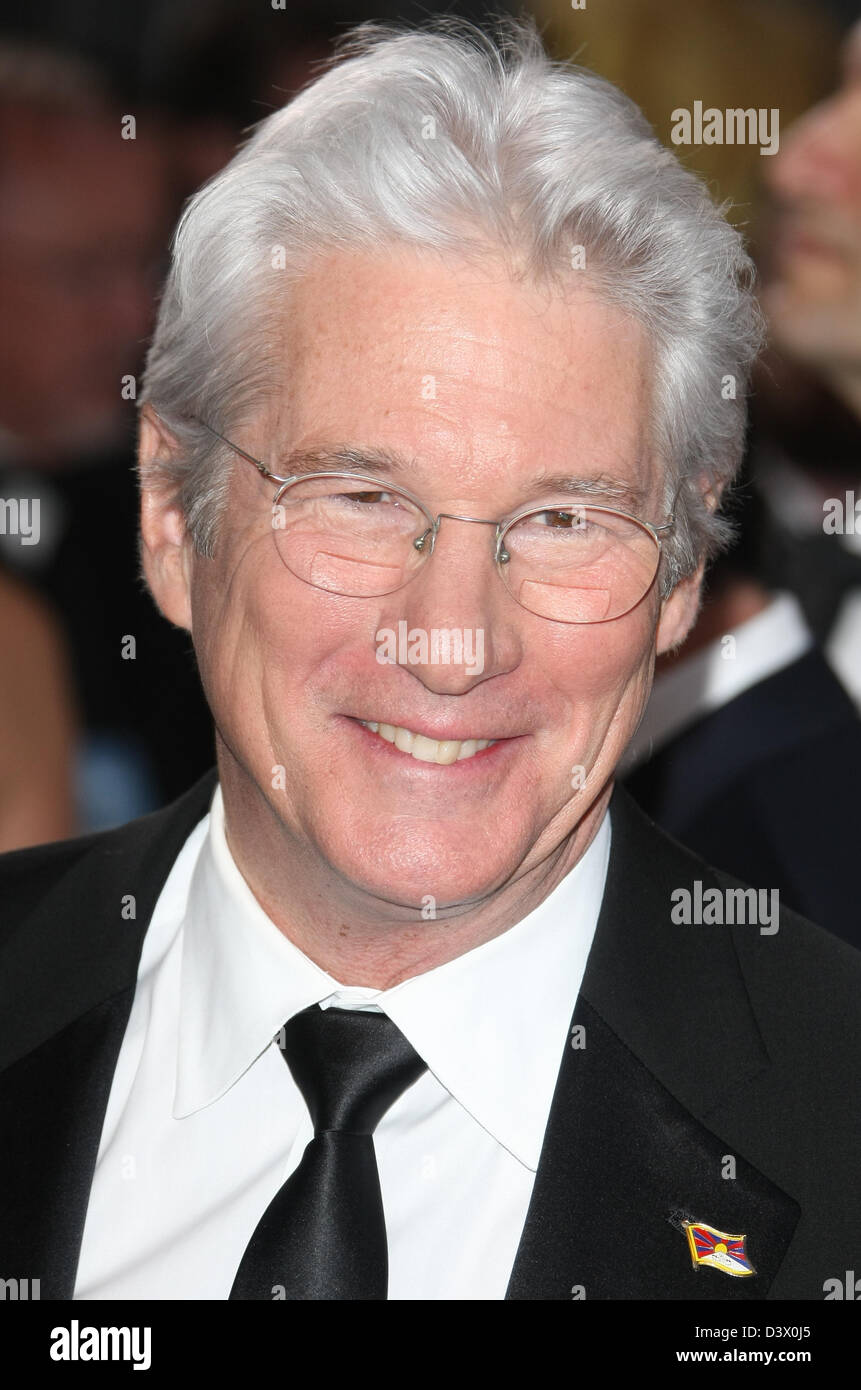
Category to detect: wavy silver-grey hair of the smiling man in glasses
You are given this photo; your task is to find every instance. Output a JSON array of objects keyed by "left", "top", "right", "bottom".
[{"left": 140, "top": 17, "right": 762, "bottom": 594}]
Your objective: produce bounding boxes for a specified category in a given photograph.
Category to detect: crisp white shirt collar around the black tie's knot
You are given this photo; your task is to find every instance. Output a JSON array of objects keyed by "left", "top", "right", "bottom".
[{"left": 174, "top": 788, "right": 611, "bottom": 1172}]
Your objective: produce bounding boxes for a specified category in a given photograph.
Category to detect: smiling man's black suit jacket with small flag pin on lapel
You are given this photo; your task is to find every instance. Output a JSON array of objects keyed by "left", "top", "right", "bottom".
[{"left": 0, "top": 774, "right": 861, "bottom": 1301}]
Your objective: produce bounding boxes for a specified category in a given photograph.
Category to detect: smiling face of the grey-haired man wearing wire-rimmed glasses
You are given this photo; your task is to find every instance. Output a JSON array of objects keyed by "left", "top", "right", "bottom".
[{"left": 151, "top": 252, "right": 693, "bottom": 908}]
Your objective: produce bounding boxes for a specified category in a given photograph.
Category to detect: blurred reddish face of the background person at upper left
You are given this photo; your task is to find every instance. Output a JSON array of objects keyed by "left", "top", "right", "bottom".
[{"left": 0, "top": 113, "right": 170, "bottom": 455}]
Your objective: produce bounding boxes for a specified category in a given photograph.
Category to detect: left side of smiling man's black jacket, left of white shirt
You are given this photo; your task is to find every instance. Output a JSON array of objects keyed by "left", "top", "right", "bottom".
[{"left": 0, "top": 773, "right": 216, "bottom": 1298}]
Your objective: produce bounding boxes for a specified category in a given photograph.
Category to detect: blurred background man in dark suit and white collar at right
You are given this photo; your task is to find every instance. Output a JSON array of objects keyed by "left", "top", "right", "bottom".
[{"left": 625, "top": 25, "right": 861, "bottom": 947}]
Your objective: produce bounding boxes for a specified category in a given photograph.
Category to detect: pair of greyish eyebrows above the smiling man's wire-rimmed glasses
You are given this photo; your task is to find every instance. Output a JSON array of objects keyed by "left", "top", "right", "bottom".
[{"left": 277, "top": 445, "right": 647, "bottom": 510}]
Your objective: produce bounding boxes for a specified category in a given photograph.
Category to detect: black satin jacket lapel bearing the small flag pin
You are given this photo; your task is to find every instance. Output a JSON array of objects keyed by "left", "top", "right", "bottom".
[{"left": 506, "top": 791, "right": 800, "bottom": 1300}]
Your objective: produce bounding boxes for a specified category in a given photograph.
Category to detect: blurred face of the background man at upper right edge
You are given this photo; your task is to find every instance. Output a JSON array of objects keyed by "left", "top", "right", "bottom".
[{"left": 764, "top": 24, "right": 861, "bottom": 370}]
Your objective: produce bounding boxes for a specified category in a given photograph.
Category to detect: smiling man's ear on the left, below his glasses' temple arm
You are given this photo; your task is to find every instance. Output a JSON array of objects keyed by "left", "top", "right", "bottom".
[{"left": 138, "top": 404, "right": 192, "bottom": 632}]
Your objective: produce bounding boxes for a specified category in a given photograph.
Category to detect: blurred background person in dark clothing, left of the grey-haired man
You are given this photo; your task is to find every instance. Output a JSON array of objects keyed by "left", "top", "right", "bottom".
[{"left": 0, "top": 46, "right": 211, "bottom": 828}]
